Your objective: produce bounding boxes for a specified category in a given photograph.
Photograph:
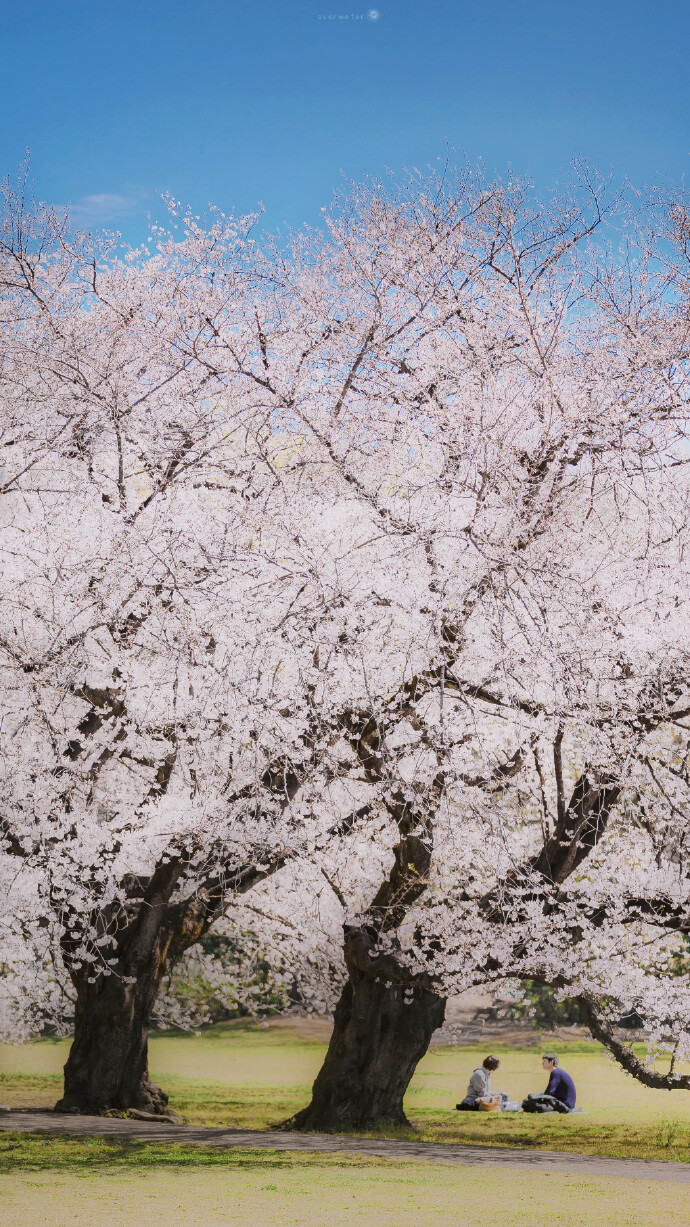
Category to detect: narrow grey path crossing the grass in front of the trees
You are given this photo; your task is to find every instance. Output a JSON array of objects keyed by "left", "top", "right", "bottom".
[{"left": 0, "top": 1109, "right": 690, "bottom": 1184}]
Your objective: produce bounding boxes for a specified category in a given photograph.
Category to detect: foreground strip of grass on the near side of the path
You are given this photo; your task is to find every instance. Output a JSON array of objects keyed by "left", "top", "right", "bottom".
[{"left": 0, "top": 1135, "right": 688, "bottom": 1227}]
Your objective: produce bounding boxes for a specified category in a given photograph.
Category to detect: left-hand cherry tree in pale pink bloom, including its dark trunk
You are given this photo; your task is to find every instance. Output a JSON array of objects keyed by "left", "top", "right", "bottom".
[{"left": 0, "top": 175, "right": 378, "bottom": 1112}]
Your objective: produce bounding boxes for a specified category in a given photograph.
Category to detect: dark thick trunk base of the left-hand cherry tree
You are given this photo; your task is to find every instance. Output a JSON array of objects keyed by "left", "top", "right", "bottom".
[{"left": 55, "top": 974, "right": 168, "bottom": 1115}]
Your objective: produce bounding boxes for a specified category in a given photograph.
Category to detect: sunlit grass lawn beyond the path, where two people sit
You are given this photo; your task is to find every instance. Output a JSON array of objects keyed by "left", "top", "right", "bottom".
[{"left": 0, "top": 1022, "right": 690, "bottom": 1163}]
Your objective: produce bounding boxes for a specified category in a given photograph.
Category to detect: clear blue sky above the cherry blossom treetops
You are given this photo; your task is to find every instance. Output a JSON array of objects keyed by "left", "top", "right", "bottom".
[{"left": 0, "top": 0, "right": 690, "bottom": 242}]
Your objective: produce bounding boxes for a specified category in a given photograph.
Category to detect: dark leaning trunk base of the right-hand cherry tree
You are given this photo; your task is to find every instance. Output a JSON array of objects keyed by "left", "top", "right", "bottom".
[{"left": 285, "top": 966, "right": 446, "bottom": 1133}]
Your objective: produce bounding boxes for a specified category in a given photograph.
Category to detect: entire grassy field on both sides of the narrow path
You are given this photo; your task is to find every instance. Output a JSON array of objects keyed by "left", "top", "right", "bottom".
[{"left": 0, "top": 1023, "right": 690, "bottom": 1227}]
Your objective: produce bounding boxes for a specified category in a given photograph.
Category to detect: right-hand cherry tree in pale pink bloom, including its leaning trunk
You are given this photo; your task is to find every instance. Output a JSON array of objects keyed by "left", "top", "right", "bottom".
[{"left": 262, "top": 170, "right": 690, "bottom": 1129}]
